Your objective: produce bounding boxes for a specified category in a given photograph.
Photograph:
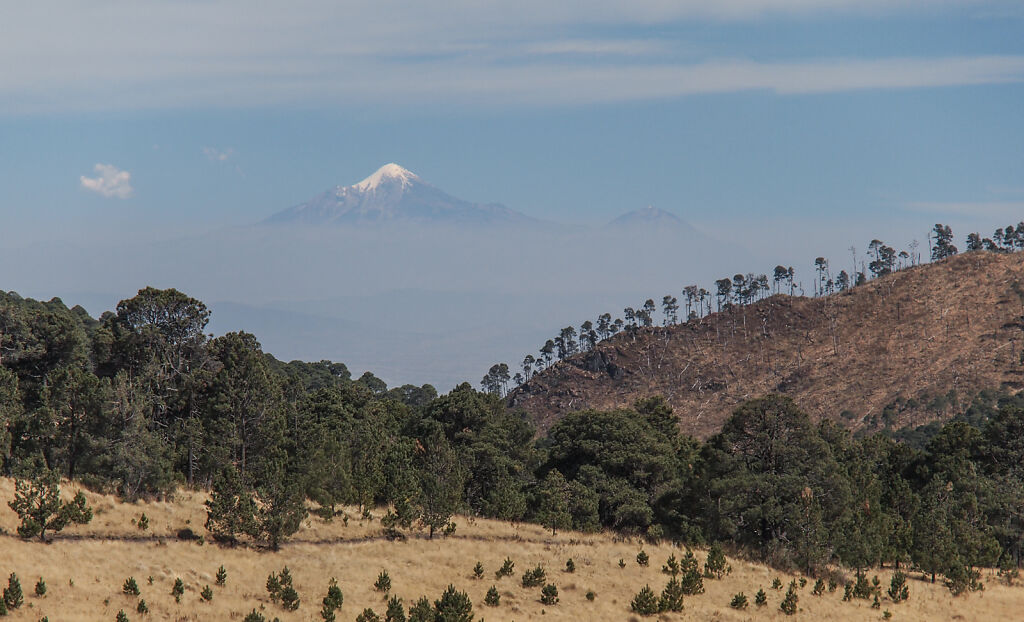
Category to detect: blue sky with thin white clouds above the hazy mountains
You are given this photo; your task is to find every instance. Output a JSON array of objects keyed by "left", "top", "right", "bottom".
[{"left": 0, "top": 0, "right": 1024, "bottom": 389}]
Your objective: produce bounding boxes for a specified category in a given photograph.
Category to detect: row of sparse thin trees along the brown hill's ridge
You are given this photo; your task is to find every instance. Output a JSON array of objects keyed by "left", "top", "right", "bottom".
[{"left": 480, "top": 221, "right": 1024, "bottom": 397}]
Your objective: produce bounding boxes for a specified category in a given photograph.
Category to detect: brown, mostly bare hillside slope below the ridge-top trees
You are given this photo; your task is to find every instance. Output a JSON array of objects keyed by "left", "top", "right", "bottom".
[{"left": 509, "top": 251, "right": 1024, "bottom": 438}]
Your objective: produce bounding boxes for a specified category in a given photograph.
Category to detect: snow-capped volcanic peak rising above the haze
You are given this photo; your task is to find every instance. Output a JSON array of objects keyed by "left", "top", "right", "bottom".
[{"left": 264, "top": 163, "right": 539, "bottom": 226}]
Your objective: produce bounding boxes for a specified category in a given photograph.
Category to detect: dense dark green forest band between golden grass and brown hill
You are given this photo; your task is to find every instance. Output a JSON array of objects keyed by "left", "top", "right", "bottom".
[{"left": 0, "top": 221, "right": 1024, "bottom": 590}]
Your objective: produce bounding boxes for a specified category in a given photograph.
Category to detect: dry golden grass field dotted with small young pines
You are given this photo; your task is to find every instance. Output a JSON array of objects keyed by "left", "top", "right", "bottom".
[{"left": 0, "top": 480, "right": 1024, "bottom": 622}]
